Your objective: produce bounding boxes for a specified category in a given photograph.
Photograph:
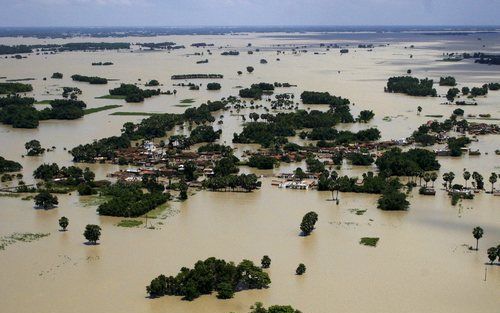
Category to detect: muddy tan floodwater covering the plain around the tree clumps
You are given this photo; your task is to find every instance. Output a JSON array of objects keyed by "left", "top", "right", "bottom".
[{"left": 0, "top": 30, "right": 500, "bottom": 313}]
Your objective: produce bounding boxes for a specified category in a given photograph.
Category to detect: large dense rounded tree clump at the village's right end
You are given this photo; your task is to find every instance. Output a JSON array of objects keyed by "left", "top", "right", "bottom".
[{"left": 375, "top": 148, "right": 441, "bottom": 176}]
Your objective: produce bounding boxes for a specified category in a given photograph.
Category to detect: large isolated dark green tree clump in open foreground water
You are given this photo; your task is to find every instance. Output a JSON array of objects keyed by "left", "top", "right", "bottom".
[{"left": 146, "top": 257, "right": 271, "bottom": 301}]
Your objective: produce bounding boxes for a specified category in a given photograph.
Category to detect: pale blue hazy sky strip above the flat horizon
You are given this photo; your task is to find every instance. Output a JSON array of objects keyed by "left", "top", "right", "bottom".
[{"left": 0, "top": 0, "right": 500, "bottom": 26}]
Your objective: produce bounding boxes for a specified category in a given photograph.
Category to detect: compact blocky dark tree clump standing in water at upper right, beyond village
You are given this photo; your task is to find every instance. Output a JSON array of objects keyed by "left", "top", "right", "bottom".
[{"left": 385, "top": 76, "right": 437, "bottom": 97}]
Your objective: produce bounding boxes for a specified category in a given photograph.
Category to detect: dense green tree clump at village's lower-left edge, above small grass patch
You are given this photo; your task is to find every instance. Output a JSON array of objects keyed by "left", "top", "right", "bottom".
[{"left": 97, "top": 177, "right": 170, "bottom": 217}]
